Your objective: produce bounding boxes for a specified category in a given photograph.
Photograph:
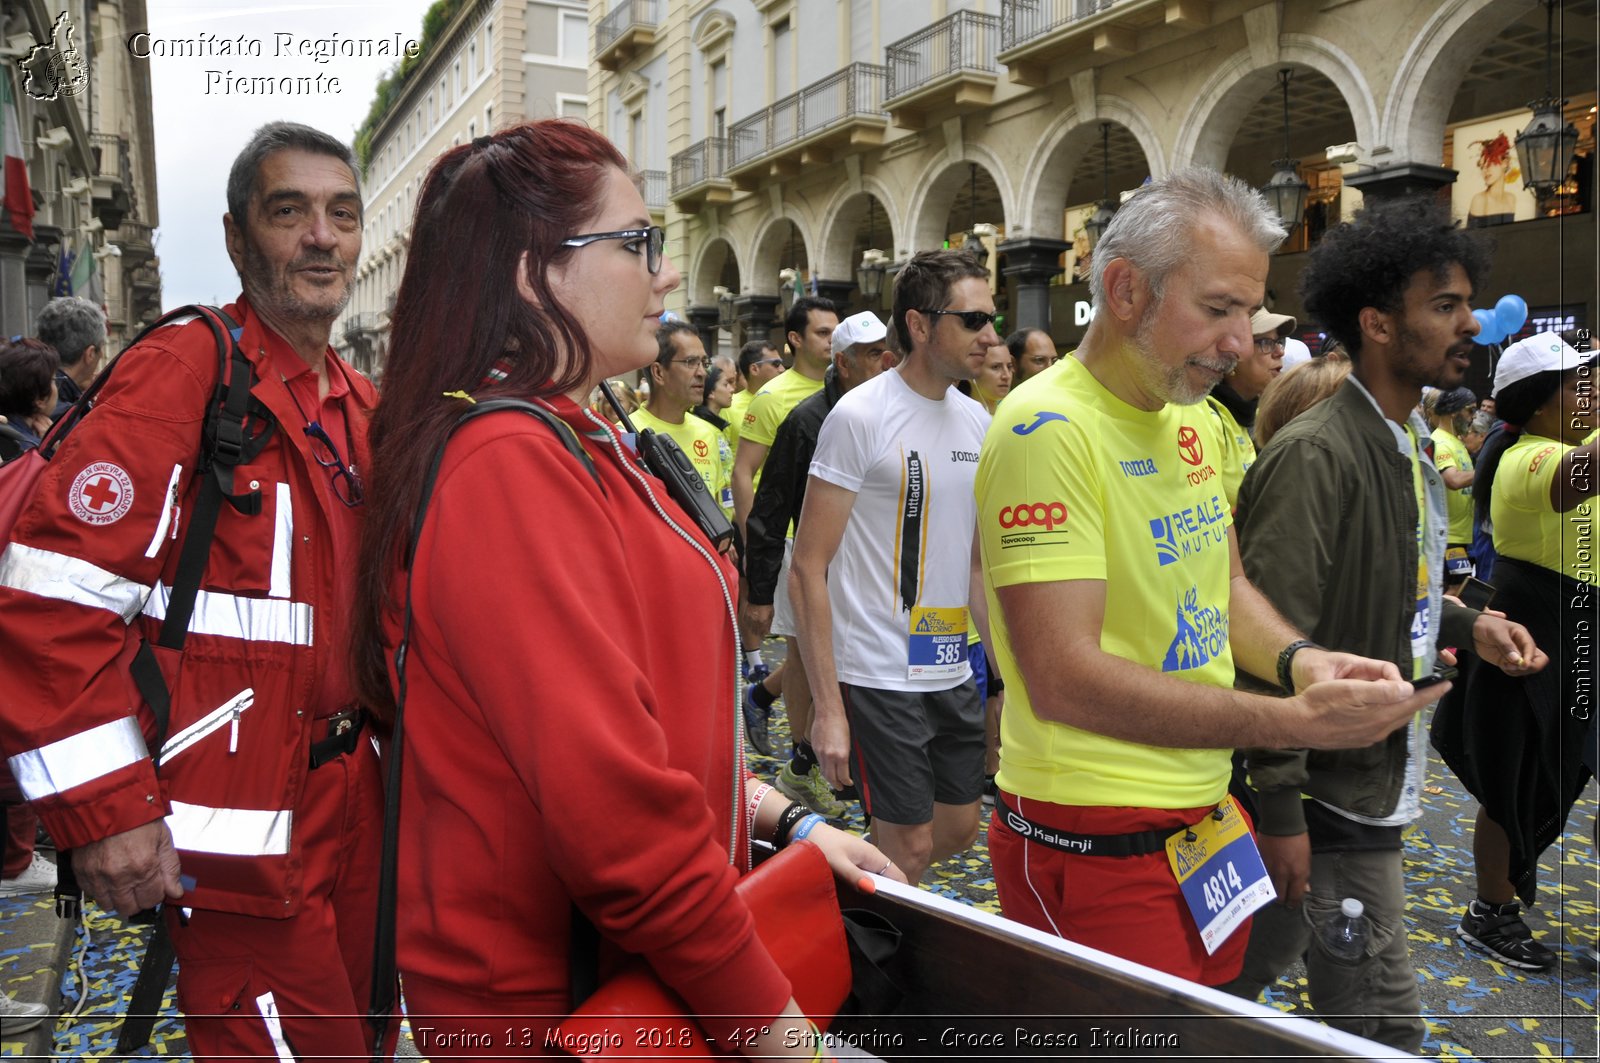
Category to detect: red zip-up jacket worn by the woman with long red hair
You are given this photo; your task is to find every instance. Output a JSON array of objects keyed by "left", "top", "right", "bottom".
[{"left": 389, "top": 399, "right": 790, "bottom": 1058}]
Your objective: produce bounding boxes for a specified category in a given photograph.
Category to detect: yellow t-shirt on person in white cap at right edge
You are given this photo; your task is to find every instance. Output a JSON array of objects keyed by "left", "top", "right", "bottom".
[{"left": 1490, "top": 432, "right": 1597, "bottom": 584}]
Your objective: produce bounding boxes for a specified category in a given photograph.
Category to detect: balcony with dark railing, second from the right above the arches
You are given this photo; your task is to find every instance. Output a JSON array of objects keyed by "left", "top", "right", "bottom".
[{"left": 883, "top": 11, "right": 1000, "bottom": 130}]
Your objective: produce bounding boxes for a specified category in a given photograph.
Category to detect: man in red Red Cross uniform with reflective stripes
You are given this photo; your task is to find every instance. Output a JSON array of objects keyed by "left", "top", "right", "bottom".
[{"left": 0, "top": 123, "right": 382, "bottom": 1060}]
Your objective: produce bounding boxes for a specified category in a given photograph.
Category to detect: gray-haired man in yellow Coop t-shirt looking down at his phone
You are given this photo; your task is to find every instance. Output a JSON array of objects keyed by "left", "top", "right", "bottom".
[{"left": 976, "top": 168, "right": 1435, "bottom": 985}]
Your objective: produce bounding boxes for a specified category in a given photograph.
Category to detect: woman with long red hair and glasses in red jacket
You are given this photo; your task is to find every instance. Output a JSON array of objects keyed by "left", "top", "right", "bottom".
[{"left": 354, "top": 120, "right": 893, "bottom": 1060}]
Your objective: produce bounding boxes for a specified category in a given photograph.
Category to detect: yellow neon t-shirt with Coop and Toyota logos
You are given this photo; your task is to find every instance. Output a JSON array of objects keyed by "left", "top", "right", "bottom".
[{"left": 976, "top": 355, "right": 1234, "bottom": 808}]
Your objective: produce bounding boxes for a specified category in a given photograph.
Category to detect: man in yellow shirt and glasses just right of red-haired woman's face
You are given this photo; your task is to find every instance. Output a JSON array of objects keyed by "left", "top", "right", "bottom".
[{"left": 630, "top": 322, "right": 733, "bottom": 515}]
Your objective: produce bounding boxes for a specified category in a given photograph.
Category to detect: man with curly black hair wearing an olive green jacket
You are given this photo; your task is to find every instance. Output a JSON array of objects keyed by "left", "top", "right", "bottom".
[{"left": 1227, "top": 199, "right": 1546, "bottom": 1052}]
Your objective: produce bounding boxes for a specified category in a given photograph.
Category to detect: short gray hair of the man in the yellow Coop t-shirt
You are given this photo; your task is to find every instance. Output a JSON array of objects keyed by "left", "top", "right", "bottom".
[{"left": 1090, "top": 166, "right": 1288, "bottom": 311}]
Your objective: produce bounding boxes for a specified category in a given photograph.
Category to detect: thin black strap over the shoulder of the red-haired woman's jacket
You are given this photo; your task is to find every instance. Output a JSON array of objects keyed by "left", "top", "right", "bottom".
[{"left": 366, "top": 399, "right": 605, "bottom": 1063}]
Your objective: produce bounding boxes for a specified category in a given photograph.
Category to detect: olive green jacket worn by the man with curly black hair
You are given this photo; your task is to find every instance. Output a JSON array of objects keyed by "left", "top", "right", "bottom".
[{"left": 1234, "top": 376, "right": 1478, "bottom": 834}]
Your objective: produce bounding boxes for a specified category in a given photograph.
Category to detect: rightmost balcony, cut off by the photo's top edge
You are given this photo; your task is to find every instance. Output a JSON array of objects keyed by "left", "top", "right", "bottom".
[{"left": 998, "top": 0, "right": 1211, "bottom": 85}]
